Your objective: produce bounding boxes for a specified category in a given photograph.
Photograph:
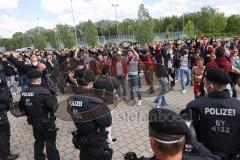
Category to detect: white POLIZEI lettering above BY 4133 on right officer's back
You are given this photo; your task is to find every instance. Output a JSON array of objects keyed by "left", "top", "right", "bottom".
[{"left": 205, "top": 108, "right": 236, "bottom": 116}]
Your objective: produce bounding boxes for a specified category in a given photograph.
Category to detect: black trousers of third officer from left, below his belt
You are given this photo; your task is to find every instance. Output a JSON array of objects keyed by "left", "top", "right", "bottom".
[{"left": 80, "top": 141, "right": 112, "bottom": 160}]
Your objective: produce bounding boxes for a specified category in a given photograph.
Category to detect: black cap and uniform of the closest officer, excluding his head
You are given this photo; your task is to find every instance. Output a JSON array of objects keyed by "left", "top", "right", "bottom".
[{"left": 124, "top": 108, "right": 219, "bottom": 160}]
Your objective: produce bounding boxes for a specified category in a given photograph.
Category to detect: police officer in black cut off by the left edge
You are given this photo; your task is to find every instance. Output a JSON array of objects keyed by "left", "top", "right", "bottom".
[{"left": 0, "top": 81, "right": 19, "bottom": 160}]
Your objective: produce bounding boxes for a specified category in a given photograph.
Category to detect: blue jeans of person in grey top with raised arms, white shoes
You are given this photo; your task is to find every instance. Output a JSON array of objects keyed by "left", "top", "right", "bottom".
[{"left": 128, "top": 75, "right": 142, "bottom": 100}]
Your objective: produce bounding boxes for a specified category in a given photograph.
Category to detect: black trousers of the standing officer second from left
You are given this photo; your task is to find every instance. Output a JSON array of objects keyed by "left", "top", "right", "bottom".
[{"left": 32, "top": 121, "right": 60, "bottom": 160}]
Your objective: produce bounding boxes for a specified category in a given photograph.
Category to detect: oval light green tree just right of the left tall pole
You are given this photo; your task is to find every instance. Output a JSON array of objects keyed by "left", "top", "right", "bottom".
[{"left": 83, "top": 20, "right": 98, "bottom": 46}]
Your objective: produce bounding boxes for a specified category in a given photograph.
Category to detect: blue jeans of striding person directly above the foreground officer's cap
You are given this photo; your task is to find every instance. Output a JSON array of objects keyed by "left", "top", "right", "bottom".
[{"left": 154, "top": 77, "right": 168, "bottom": 106}]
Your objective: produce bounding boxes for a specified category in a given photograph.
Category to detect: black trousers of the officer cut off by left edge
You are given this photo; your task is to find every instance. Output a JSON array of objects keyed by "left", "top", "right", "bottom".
[{"left": 0, "top": 113, "right": 10, "bottom": 159}]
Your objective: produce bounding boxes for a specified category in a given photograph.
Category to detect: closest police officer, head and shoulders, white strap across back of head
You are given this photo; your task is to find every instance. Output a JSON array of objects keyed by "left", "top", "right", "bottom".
[{"left": 124, "top": 108, "right": 219, "bottom": 160}]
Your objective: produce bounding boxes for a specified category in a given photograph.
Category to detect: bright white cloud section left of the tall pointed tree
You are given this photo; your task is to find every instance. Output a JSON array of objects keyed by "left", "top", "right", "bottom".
[{"left": 42, "top": 0, "right": 142, "bottom": 24}]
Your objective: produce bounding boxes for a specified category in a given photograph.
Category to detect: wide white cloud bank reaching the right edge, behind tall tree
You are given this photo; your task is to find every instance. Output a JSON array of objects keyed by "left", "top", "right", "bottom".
[{"left": 41, "top": 0, "right": 240, "bottom": 25}]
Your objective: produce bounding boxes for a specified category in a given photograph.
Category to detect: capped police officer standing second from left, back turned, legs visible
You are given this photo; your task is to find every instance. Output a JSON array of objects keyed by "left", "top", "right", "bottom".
[{"left": 19, "top": 70, "right": 60, "bottom": 160}]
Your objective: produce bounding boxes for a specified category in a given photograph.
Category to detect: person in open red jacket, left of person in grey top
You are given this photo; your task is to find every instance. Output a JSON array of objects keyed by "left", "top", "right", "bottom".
[{"left": 111, "top": 52, "right": 127, "bottom": 101}]
